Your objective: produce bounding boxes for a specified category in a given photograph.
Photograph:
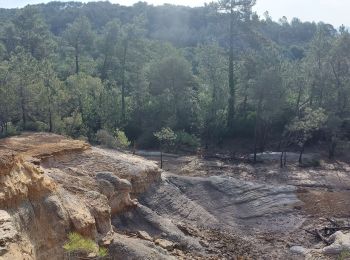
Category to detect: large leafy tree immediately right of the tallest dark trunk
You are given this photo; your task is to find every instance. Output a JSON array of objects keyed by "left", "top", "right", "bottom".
[{"left": 239, "top": 46, "right": 286, "bottom": 162}]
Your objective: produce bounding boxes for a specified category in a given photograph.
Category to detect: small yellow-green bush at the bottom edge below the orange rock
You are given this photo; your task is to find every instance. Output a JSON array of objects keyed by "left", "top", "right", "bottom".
[{"left": 63, "top": 233, "right": 108, "bottom": 257}]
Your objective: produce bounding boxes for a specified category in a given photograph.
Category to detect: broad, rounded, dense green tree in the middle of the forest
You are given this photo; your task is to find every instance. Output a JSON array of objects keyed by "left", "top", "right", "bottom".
[{"left": 148, "top": 54, "right": 198, "bottom": 133}]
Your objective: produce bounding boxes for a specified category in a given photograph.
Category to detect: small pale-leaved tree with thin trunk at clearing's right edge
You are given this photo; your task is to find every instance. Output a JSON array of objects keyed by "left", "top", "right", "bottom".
[{"left": 287, "top": 108, "right": 327, "bottom": 164}]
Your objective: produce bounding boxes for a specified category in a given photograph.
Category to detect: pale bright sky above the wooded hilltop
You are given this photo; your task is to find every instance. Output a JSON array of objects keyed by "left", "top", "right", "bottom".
[{"left": 0, "top": 0, "right": 350, "bottom": 27}]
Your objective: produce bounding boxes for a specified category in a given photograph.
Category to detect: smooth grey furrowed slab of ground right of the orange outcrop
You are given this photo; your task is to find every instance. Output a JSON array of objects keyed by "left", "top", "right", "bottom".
[{"left": 135, "top": 174, "right": 302, "bottom": 234}]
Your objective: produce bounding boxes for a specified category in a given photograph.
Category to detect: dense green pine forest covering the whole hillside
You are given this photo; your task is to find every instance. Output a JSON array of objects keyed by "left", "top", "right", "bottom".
[{"left": 0, "top": 0, "right": 350, "bottom": 157}]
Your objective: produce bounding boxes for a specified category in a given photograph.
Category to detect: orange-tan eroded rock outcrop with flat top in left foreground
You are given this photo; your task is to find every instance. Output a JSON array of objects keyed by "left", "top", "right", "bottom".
[{"left": 0, "top": 133, "right": 160, "bottom": 260}]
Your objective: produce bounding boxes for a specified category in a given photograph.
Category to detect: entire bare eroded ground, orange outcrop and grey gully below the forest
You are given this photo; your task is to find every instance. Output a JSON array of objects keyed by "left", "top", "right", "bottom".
[{"left": 0, "top": 133, "right": 350, "bottom": 259}]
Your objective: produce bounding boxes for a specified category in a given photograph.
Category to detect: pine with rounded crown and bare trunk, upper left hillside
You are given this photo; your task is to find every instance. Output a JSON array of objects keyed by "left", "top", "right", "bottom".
[{"left": 64, "top": 16, "right": 93, "bottom": 74}]
